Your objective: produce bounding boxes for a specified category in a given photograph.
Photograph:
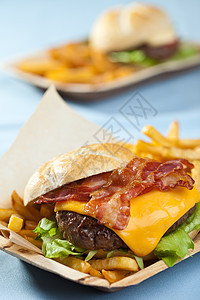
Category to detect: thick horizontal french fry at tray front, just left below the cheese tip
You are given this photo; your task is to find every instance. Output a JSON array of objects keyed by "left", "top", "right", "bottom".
[{"left": 90, "top": 256, "right": 139, "bottom": 272}]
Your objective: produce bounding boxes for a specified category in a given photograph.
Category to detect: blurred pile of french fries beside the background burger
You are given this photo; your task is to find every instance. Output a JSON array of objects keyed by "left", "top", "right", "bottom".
[{"left": 18, "top": 42, "right": 133, "bottom": 84}]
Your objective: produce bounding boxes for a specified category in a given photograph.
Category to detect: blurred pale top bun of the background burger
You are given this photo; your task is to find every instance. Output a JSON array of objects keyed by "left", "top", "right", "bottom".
[{"left": 89, "top": 3, "right": 176, "bottom": 52}]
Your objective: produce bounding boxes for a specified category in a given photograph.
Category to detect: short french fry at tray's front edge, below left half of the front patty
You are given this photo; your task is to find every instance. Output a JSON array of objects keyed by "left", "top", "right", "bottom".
[{"left": 55, "top": 256, "right": 91, "bottom": 274}]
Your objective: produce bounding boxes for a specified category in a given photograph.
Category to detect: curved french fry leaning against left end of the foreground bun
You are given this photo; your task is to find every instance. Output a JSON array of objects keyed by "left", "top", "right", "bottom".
[{"left": 11, "top": 191, "right": 41, "bottom": 222}]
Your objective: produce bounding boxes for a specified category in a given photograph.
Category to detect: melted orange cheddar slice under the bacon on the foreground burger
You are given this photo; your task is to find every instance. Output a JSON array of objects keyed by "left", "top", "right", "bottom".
[{"left": 55, "top": 187, "right": 200, "bottom": 256}]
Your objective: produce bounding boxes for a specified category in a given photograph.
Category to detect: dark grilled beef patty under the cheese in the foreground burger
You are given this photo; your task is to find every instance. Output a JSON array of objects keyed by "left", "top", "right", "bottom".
[{"left": 56, "top": 206, "right": 195, "bottom": 251}]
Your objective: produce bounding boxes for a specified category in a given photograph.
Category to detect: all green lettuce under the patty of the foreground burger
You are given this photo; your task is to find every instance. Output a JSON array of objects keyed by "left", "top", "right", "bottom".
[{"left": 34, "top": 203, "right": 200, "bottom": 269}]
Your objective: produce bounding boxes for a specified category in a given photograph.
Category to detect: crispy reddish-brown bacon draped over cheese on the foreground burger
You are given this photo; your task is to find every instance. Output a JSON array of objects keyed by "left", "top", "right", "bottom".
[{"left": 36, "top": 157, "right": 194, "bottom": 230}]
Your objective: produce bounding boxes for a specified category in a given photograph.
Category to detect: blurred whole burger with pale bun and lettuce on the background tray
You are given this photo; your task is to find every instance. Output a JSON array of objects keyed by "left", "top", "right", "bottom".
[{"left": 89, "top": 3, "right": 193, "bottom": 66}]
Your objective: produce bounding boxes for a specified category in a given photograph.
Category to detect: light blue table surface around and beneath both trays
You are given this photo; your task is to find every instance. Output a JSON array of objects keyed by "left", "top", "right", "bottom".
[{"left": 0, "top": 0, "right": 200, "bottom": 300}]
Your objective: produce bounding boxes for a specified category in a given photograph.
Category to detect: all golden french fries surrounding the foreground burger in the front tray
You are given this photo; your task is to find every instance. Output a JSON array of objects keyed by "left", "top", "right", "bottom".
[{"left": 0, "top": 122, "right": 200, "bottom": 283}]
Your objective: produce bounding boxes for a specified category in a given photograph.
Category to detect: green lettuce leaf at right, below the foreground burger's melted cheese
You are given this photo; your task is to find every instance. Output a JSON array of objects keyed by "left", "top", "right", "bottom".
[{"left": 154, "top": 203, "right": 200, "bottom": 267}]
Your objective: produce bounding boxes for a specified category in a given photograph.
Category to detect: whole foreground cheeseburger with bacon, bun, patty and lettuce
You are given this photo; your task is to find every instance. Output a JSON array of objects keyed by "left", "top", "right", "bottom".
[{"left": 24, "top": 144, "right": 200, "bottom": 266}]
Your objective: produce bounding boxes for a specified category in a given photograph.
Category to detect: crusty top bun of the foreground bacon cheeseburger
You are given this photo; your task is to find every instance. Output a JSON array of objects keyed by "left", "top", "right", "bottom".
[{"left": 24, "top": 143, "right": 134, "bottom": 205}]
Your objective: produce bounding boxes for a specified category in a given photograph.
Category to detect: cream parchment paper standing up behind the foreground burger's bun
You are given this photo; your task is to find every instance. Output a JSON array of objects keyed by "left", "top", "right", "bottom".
[{"left": 0, "top": 86, "right": 100, "bottom": 208}]
